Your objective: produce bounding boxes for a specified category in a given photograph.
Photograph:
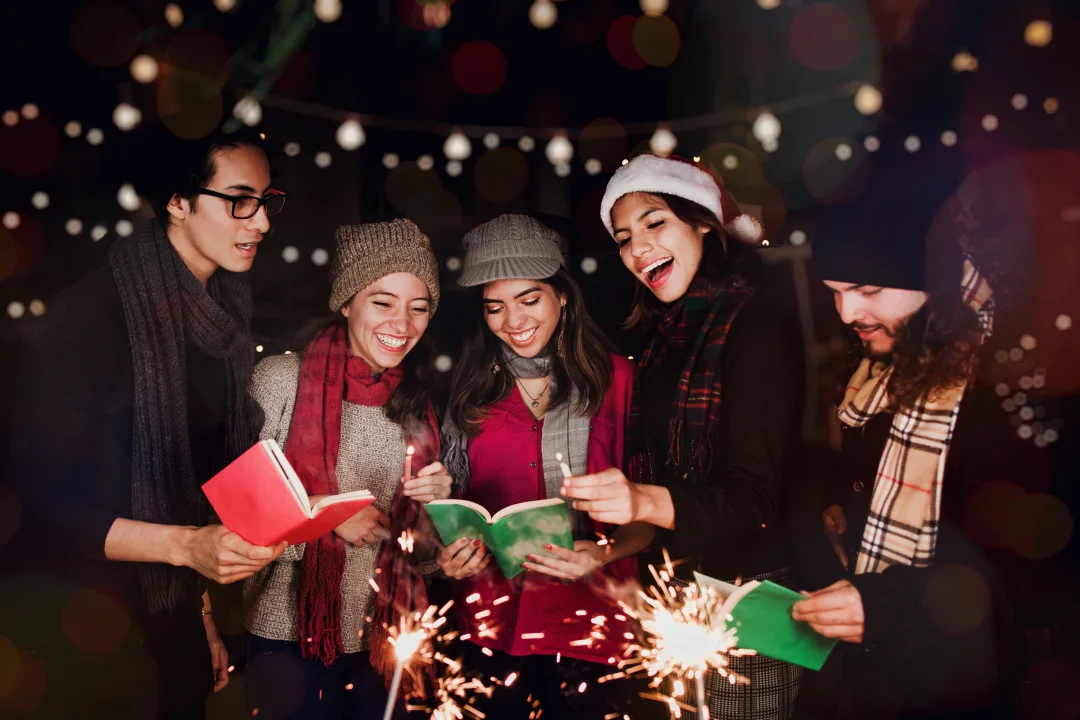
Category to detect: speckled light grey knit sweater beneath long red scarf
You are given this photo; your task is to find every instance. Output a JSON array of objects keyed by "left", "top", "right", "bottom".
[{"left": 244, "top": 355, "right": 405, "bottom": 652}]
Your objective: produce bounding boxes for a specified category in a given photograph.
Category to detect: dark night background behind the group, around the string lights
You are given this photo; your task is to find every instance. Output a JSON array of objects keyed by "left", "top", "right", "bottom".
[{"left": 0, "top": 0, "right": 1080, "bottom": 717}]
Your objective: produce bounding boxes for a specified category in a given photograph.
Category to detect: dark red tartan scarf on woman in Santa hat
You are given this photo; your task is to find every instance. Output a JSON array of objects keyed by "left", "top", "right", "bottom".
[{"left": 626, "top": 267, "right": 754, "bottom": 483}]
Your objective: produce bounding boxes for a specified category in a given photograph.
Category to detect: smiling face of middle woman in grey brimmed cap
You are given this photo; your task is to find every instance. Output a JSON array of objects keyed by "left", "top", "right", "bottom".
[{"left": 484, "top": 279, "right": 566, "bottom": 357}]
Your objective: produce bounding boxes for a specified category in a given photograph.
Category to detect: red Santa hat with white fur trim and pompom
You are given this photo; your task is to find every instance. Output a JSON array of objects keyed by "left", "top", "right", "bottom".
[{"left": 600, "top": 154, "right": 765, "bottom": 245}]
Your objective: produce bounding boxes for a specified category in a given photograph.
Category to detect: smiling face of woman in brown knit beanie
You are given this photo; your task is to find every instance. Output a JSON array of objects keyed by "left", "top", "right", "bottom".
[{"left": 341, "top": 272, "right": 431, "bottom": 372}]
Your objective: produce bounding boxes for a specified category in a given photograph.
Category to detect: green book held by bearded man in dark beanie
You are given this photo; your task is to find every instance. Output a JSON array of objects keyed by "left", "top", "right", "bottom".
[{"left": 693, "top": 572, "right": 836, "bottom": 670}]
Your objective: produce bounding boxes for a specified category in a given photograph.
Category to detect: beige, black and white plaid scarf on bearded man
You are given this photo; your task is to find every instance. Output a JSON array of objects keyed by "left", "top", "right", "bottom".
[{"left": 837, "top": 257, "right": 994, "bottom": 574}]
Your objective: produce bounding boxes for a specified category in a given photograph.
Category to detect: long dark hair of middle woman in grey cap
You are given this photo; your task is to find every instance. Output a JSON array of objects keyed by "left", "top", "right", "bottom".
[{"left": 449, "top": 268, "right": 613, "bottom": 437}]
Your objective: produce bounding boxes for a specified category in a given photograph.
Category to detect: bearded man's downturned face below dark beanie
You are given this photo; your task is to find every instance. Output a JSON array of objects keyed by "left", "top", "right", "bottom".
[{"left": 825, "top": 281, "right": 928, "bottom": 358}]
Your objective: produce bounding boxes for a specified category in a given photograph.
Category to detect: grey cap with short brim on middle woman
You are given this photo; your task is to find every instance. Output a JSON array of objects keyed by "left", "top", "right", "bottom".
[{"left": 458, "top": 215, "right": 563, "bottom": 287}]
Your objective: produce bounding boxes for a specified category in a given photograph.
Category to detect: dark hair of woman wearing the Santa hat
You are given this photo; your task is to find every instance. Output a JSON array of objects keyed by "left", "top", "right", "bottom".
[{"left": 625, "top": 192, "right": 761, "bottom": 329}]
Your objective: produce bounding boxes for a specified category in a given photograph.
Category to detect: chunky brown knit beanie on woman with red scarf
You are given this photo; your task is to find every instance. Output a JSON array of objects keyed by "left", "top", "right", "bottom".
[{"left": 330, "top": 218, "right": 438, "bottom": 315}]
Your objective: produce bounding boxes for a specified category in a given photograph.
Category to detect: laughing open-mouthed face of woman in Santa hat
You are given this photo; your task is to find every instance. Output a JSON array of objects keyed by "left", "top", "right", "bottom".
[{"left": 611, "top": 192, "right": 710, "bottom": 302}]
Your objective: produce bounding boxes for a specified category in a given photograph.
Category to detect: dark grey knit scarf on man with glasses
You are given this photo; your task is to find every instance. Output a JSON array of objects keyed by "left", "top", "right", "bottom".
[{"left": 109, "top": 221, "right": 261, "bottom": 613}]
